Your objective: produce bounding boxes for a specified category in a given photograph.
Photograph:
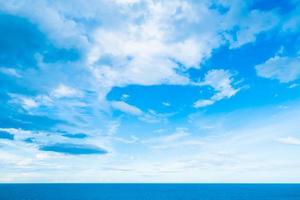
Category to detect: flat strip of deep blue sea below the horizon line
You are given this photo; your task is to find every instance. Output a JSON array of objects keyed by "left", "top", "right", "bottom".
[{"left": 0, "top": 184, "right": 300, "bottom": 200}]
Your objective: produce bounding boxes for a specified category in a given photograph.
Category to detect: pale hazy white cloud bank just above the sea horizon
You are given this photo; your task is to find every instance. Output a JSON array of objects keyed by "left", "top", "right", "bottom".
[{"left": 0, "top": 102, "right": 300, "bottom": 182}]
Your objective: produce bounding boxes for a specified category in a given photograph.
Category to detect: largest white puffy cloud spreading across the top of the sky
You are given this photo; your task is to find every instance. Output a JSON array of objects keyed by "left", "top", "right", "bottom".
[{"left": 0, "top": 0, "right": 278, "bottom": 110}]
